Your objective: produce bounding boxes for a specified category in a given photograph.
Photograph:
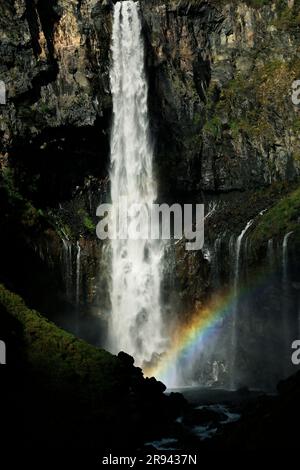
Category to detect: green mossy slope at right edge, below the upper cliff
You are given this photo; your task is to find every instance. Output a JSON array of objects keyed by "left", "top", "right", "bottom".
[{"left": 251, "top": 188, "right": 300, "bottom": 246}]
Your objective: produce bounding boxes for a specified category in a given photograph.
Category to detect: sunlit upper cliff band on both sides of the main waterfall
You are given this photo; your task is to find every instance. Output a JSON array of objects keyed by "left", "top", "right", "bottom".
[{"left": 0, "top": 0, "right": 300, "bottom": 196}]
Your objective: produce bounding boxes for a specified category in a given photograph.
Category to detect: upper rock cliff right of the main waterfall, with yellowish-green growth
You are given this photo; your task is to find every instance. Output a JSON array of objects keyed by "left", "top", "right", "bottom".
[{"left": 143, "top": 1, "right": 300, "bottom": 195}]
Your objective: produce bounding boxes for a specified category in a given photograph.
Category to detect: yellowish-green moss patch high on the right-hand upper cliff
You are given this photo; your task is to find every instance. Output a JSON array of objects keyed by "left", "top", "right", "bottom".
[{"left": 204, "top": 56, "right": 300, "bottom": 144}]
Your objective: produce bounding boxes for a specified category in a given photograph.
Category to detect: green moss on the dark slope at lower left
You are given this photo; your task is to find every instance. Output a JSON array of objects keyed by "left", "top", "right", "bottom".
[{"left": 0, "top": 285, "right": 117, "bottom": 393}]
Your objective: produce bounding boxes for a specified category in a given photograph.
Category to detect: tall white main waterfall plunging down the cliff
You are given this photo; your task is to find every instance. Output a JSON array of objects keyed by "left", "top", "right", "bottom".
[{"left": 109, "top": 1, "right": 165, "bottom": 365}]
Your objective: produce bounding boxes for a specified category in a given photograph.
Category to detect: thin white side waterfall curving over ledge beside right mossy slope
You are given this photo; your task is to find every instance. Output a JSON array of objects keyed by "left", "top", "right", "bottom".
[{"left": 230, "top": 219, "right": 253, "bottom": 388}]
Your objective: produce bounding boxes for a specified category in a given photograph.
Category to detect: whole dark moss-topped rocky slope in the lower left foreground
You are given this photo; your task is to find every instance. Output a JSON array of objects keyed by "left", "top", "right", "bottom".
[{"left": 0, "top": 285, "right": 183, "bottom": 452}]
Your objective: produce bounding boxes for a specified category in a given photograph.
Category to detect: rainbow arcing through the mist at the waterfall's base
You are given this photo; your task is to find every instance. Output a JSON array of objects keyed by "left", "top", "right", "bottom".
[{"left": 144, "top": 271, "right": 270, "bottom": 386}]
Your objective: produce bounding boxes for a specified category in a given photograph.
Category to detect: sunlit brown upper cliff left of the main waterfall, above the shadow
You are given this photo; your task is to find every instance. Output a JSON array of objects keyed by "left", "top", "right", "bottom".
[{"left": 1, "top": 0, "right": 109, "bottom": 149}]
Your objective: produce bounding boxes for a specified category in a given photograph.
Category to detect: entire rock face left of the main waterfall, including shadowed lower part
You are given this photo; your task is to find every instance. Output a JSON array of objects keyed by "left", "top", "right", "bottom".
[{"left": 0, "top": 0, "right": 111, "bottom": 323}]
